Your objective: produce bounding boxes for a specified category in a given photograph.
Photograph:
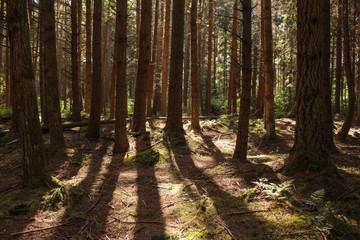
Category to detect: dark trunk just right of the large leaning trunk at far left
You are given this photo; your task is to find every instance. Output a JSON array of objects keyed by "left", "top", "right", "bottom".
[{"left": 40, "top": 0, "right": 65, "bottom": 148}]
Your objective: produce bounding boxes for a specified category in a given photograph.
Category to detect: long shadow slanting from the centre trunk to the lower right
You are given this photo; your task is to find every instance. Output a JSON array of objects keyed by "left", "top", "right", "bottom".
[{"left": 165, "top": 135, "right": 280, "bottom": 239}]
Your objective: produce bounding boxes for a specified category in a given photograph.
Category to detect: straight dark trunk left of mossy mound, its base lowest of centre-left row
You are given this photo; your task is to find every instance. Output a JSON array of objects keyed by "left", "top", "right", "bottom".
[{"left": 114, "top": 0, "right": 129, "bottom": 153}]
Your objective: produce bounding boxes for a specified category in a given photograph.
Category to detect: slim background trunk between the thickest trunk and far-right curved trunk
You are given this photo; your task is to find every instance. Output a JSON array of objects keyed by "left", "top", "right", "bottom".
[{"left": 335, "top": 0, "right": 343, "bottom": 113}]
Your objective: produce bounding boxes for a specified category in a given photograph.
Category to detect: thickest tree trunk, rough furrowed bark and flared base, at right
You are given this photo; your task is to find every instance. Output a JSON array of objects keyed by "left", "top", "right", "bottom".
[{"left": 284, "top": 0, "right": 336, "bottom": 175}]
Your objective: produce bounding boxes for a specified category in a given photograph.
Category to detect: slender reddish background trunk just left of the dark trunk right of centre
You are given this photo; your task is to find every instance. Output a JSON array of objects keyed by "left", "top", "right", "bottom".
[{"left": 227, "top": 0, "right": 238, "bottom": 113}]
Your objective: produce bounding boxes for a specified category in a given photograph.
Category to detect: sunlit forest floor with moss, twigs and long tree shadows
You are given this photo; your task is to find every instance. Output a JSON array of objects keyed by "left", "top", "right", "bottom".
[{"left": 0, "top": 116, "right": 360, "bottom": 240}]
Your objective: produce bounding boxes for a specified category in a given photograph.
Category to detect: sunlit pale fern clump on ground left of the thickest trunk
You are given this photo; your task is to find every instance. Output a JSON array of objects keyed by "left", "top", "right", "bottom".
[{"left": 253, "top": 178, "right": 294, "bottom": 200}]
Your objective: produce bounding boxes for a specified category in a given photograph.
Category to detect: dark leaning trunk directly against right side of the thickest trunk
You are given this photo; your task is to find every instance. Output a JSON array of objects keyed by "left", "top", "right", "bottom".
[{"left": 320, "top": 0, "right": 337, "bottom": 152}]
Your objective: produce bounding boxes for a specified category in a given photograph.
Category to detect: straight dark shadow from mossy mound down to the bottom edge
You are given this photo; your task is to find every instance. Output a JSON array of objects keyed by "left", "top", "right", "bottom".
[{"left": 133, "top": 137, "right": 165, "bottom": 240}]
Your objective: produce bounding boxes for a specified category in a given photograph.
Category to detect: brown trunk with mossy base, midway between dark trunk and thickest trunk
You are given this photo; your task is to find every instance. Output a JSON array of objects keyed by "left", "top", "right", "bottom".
[{"left": 263, "top": 0, "right": 276, "bottom": 139}]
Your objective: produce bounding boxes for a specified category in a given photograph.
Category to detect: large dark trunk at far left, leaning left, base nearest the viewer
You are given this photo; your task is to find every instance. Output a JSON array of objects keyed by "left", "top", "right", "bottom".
[{"left": 7, "top": 0, "right": 50, "bottom": 186}]
